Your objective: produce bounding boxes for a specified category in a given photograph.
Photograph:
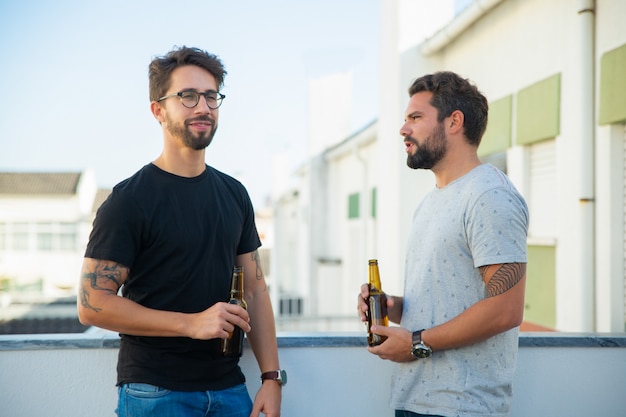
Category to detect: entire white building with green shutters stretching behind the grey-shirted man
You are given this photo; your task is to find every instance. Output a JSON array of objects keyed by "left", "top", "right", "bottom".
[{"left": 274, "top": 0, "right": 626, "bottom": 332}]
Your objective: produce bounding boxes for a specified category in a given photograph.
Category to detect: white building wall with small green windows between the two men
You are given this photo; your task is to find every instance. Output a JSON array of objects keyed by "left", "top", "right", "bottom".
[{"left": 274, "top": 124, "right": 378, "bottom": 331}]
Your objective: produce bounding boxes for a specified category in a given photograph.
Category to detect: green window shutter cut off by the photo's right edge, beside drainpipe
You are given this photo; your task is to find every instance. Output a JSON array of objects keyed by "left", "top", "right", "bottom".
[{"left": 599, "top": 45, "right": 626, "bottom": 125}]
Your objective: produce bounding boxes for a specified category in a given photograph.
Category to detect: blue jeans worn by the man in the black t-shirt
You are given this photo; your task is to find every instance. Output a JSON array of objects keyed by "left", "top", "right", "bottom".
[{"left": 115, "top": 383, "right": 252, "bottom": 417}]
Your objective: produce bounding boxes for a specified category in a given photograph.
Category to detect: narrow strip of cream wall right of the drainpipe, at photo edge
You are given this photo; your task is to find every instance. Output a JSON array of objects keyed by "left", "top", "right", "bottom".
[{"left": 594, "top": 0, "right": 626, "bottom": 331}]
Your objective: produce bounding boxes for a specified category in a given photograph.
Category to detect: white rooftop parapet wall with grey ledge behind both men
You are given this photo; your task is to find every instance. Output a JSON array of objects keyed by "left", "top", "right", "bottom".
[{"left": 0, "top": 333, "right": 626, "bottom": 417}]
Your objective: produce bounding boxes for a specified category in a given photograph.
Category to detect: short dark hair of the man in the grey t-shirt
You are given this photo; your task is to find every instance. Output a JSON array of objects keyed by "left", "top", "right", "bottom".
[{"left": 409, "top": 71, "right": 489, "bottom": 147}]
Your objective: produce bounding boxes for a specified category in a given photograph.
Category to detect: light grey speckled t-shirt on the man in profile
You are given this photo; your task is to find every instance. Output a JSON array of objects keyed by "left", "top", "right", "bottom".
[{"left": 390, "top": 164, "right": 528, "bottom": 417}]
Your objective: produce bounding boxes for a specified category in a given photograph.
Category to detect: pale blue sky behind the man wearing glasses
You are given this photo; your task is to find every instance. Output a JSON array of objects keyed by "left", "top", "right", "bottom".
[{"left": 0, "top": 0, "right": 380, "bottom": 206}]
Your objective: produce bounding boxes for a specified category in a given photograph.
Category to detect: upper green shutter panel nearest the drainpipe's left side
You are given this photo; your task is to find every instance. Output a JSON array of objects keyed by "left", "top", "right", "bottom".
[{"left": 516, "top": 74, "right": 561, "bottom": 145}]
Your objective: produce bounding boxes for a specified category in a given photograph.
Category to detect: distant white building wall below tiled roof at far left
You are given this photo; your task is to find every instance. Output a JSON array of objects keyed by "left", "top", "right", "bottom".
[{"left": 0, "top": 171, "right": 97, "bottom": 296}]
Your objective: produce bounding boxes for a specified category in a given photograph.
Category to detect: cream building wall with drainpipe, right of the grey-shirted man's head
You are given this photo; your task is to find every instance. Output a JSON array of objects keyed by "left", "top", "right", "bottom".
[{"left": 390, "top": 0, "right": 626, "bottom": 331}]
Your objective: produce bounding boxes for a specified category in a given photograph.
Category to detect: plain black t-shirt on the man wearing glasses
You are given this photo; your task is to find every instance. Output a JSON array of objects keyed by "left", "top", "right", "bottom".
[{"left": 85, "top": 164, "right": 261, "bottom": 391}]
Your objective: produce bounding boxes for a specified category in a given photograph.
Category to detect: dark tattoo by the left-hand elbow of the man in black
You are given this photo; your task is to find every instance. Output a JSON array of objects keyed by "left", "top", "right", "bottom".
[{"left": 79, "top": 261, "right": 128, "bottom": 312}]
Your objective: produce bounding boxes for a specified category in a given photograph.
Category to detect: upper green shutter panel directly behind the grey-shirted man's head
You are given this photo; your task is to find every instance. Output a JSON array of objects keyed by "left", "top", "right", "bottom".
[{"left": 478, "top": 96, "right": 513, "bottom": 156}]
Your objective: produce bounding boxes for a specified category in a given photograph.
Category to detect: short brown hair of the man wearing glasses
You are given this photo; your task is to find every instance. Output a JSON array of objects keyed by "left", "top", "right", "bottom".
[{"left": 149, "top": 46, "right": 226, "bottom": 101}]
